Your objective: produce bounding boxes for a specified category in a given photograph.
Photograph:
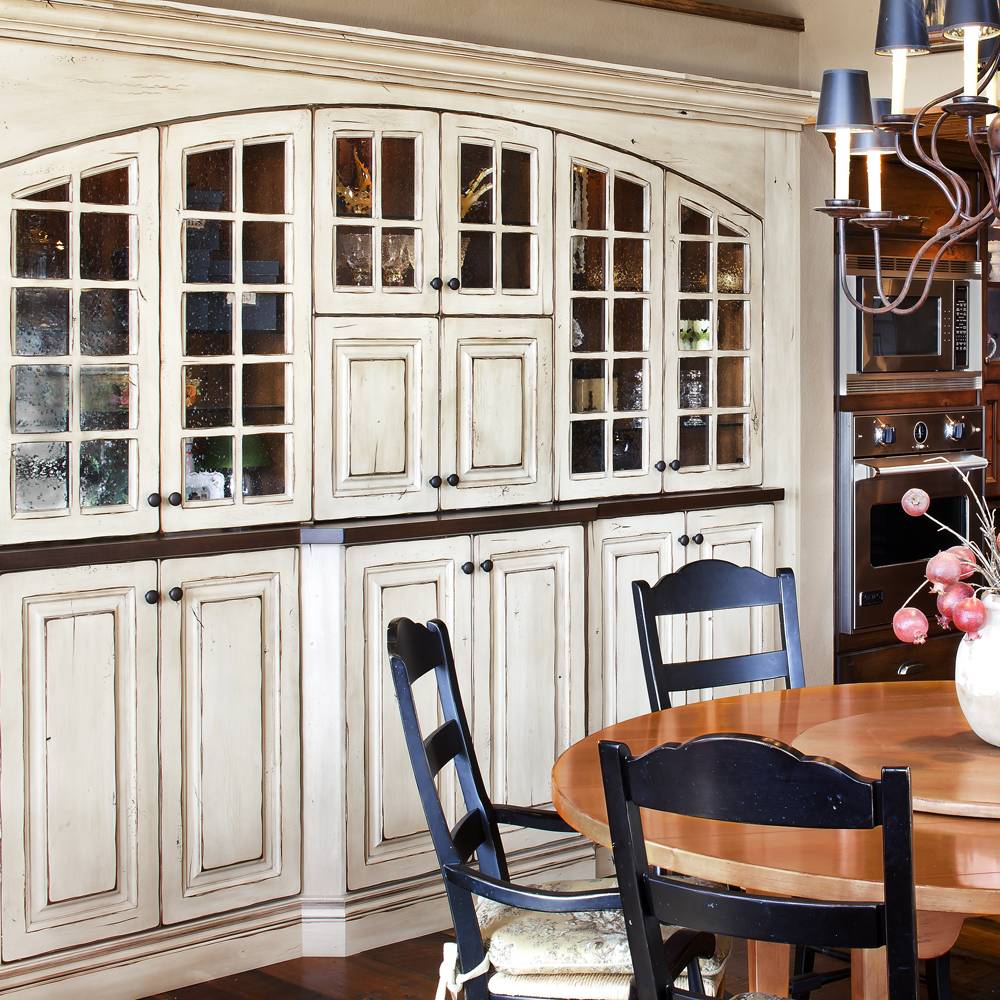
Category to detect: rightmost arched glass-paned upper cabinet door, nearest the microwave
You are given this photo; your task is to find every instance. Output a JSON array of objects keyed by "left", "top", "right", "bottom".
[{"left": 664, "top": 181, "right": 764, "bottom": 490}]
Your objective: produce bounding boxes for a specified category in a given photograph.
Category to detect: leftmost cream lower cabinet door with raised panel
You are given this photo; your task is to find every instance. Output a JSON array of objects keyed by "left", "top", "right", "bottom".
[{"left": 0, "top": 562, "right": 159, "bottom": 961}]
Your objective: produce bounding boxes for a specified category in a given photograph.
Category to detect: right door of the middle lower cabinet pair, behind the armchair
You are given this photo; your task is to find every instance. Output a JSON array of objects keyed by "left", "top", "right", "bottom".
[{"left": 472, "top": 526, "right": 586, "bottom": 849}]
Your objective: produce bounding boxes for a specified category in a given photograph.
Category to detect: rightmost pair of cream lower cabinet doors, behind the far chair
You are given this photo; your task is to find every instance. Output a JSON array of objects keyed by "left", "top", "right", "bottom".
[{"left": 589, "top": 505, "right": 775, "bottom": 730}]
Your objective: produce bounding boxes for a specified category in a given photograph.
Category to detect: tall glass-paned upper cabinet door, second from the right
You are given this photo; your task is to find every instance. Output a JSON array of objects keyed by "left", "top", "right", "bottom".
[{"left": 555, "top": 136, "right": 663, "bottom": 499}]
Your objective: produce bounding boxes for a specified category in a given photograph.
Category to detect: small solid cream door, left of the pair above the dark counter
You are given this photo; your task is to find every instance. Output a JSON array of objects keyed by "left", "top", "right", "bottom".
[{"left": 314, "top": 317, "right": 438, "bottom": 519}]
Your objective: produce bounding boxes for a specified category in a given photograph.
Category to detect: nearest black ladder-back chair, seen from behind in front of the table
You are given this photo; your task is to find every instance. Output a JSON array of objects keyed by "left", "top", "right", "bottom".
[{"left": 600, "top": 734, "right": 918, "bottom": 1000}]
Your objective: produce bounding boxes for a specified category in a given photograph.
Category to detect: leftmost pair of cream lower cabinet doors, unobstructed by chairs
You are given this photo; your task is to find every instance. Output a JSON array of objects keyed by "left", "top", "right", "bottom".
[{"left": 0, "top": 550, "right": 300, "bottom": 961}]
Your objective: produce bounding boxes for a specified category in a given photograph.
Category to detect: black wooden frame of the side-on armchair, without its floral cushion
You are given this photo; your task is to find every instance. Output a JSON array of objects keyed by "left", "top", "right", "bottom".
[{"left": 387, "top": 618, "right": 712, "bottom": 1000}]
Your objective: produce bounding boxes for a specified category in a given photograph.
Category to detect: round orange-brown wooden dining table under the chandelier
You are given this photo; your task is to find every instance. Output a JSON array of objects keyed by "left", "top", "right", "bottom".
[{"left": 552, "top": 681, "right": 1000, "bottom": 1000}]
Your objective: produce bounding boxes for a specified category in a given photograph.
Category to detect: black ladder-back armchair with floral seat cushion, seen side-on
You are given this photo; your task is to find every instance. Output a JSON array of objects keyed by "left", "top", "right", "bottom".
[{"left": 388, "top": 618, "right": 715, "bottom": 1000}]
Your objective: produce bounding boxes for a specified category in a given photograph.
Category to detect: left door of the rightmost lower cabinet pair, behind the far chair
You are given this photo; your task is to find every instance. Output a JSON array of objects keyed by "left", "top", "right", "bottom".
[{"left": 589, "top": 514, "right": 687, "bottom": 732}]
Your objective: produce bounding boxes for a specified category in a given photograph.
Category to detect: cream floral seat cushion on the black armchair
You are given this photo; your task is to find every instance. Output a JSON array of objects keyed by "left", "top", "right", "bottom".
[{"left": 476, "top": 878, "right": 732, "bottom": 1000}]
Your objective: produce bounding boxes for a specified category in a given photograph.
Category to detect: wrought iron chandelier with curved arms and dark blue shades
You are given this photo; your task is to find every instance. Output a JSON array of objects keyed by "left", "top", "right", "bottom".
[{"left": 816, "top": 0, "right": 1000, "bottom": 315}]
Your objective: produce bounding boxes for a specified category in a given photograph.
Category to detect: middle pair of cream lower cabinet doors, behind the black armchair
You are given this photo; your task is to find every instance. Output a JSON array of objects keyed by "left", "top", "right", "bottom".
[{"left": 345, "top": 526, "right": 585, "bottom": 889}]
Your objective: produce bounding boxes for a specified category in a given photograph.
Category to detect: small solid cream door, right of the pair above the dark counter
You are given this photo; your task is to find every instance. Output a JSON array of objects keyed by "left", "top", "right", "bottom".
[{"left": 441, "top": 318, "right": 552, "bottom": 510}]
